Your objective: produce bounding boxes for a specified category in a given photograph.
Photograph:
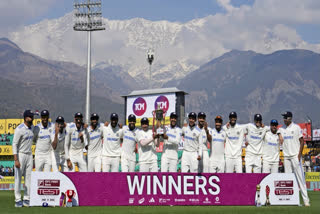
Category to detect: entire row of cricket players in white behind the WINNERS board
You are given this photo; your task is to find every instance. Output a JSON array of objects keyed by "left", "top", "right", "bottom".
[{"left": 12, "top": 110, "right": 309, "bottom": 205}]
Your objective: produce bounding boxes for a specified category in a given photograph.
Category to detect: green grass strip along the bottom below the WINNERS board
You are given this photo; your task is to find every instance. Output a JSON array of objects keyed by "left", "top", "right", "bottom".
[{"left": 0, "top": 191, "right": 320, "bottom": 214}]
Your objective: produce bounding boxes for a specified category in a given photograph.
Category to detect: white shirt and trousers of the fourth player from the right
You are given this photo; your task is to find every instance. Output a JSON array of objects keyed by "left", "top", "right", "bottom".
[{"left": 223, "top": 124, "right": 244, "bottom": 173}]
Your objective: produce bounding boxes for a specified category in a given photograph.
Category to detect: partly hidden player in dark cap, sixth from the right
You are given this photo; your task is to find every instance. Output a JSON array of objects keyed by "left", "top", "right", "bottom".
[{"left": 198, "top": 112, "right": 210, "bottom": 173}]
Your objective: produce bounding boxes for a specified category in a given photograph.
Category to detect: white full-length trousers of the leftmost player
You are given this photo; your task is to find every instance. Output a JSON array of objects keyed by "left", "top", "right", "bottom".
[{"left": 14, "top": 153, "right": 33, "bottom": 202}]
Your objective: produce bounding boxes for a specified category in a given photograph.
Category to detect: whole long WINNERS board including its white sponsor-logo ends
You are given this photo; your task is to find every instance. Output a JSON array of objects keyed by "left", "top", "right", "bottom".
[{"left": 30, "top": 172, "right": 299, "bottom": 206}]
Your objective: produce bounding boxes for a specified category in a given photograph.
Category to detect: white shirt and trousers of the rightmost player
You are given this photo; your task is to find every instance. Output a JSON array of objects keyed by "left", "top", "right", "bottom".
[{"left": 279, "top": 122, "right": 309, "bottom": 204}]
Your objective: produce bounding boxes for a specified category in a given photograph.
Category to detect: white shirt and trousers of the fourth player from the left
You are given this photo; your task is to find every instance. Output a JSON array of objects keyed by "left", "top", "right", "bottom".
[{"left": 64, "top": 123, "right": 88, "bottom": 172}]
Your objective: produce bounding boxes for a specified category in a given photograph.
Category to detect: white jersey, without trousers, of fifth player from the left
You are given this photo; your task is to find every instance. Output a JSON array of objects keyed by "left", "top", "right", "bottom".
[{"left": 88, "top": 124, "right": 104, "bottom": 157}]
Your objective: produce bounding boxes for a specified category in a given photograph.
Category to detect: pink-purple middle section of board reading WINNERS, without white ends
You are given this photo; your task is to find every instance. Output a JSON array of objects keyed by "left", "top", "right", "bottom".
[{"left": 63, "top": 172, "right": 268, "bottom": 206}]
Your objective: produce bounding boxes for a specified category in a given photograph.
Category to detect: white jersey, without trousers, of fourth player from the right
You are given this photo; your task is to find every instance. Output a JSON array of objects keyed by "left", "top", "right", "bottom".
[{"left": 223, "top": 124, "right": 244, "bottom": 158}]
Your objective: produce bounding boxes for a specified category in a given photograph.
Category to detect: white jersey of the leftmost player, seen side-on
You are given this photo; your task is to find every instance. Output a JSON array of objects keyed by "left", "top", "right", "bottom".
[{"left": 12, "top": 123, "right": 34, "bottom": 155}]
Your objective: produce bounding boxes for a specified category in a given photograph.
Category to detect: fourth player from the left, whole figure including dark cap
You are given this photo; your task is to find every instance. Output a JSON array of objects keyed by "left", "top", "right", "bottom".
[{"left": 64, "top": 112, "right": 88, "bottom": 172}]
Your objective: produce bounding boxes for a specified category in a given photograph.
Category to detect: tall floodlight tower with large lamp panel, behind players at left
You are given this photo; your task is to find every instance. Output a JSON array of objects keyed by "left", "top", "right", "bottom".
[{"left": 73, "top": 0, "right": 105, "bottom": 123}]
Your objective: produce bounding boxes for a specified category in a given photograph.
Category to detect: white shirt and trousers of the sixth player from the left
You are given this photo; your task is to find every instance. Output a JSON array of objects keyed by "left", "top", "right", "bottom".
[{"left": 102, "top": 124, "right": 123, "bottom": 172}]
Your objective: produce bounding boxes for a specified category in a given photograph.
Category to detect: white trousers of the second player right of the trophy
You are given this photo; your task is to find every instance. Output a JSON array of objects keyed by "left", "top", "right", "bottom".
[{"left": 181, "top": 150, "right": 199, "bottom": 173}]
